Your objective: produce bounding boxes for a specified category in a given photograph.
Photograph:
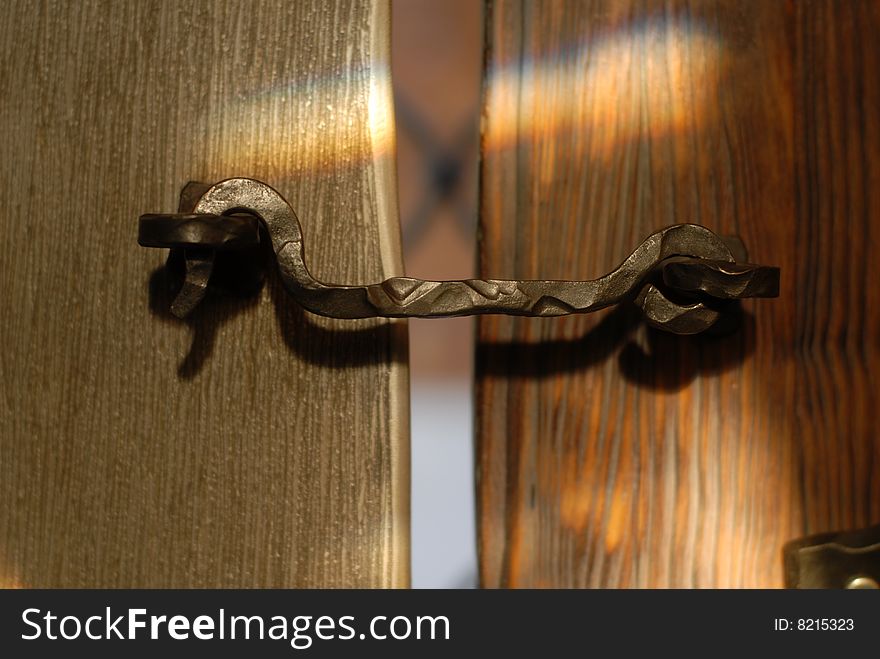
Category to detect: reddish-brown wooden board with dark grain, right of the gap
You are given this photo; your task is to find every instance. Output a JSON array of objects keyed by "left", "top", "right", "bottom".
[{"left": 476, "top": 0, "right": 880, "bottom": 587}]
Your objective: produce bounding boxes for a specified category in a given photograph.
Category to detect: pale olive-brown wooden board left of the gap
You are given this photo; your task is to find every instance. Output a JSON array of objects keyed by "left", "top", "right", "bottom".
[{"left": 0, "top": 0, "right": 409, "bottom": 587}]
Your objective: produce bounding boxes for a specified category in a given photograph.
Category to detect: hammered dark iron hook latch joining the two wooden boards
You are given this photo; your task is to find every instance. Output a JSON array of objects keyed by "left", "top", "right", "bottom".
[{"left": 138, "top": 178, "right": 779, "bottom": 334}]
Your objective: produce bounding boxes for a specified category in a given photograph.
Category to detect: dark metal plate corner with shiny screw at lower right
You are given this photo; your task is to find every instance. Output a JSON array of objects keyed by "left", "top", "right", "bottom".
[{"left": 783, "top": 524, "right": 880, "bottom": 589}]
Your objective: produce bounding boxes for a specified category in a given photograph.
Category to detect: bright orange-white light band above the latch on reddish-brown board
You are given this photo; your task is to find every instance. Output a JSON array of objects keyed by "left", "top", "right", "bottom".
[{"left": 484, "top": 20, "right": 721, "bottom": 159}]
